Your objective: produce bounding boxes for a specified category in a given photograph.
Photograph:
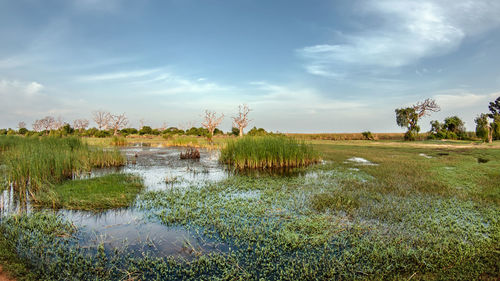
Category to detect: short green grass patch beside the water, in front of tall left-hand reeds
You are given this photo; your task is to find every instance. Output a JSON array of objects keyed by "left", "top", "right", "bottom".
[{"left": 36, "top": 174, "right": 144, "bottom": 211}]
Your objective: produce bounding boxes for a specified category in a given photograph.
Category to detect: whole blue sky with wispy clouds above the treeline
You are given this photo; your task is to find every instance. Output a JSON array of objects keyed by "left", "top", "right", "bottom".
[{"left": 0, "top": 0, "right": 500, "bottom": 133}]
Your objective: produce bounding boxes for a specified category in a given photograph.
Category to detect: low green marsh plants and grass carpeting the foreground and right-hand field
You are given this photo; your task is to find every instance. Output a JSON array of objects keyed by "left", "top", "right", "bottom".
[{"left": 0, "top": 136, "right": 500, "bottom": 280}]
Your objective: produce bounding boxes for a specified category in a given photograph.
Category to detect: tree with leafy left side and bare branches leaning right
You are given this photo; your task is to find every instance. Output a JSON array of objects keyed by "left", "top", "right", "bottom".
[{"left": 395, "top": 99, "right": 441, "bottom": 140}]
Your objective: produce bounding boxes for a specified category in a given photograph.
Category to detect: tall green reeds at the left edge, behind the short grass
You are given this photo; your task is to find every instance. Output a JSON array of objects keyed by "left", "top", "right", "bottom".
[{"left": 2, "top": 137, "right": 126, "bottom": 192}]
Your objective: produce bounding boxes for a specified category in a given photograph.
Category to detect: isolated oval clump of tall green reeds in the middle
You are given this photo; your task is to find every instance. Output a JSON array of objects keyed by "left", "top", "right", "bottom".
[{"left": 219, "top": 136, "right": 320, "bottom": 170}]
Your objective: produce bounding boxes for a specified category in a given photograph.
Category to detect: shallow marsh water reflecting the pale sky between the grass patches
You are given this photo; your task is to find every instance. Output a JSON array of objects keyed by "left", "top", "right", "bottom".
[{"left": 0, "top": 147, "right": 227, "bottom": 258}]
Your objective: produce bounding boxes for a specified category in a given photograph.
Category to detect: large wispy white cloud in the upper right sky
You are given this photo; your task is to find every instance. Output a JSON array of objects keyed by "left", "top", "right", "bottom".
[{"left": 297, "top": 0, "right": 500, "bottom": 77}]
